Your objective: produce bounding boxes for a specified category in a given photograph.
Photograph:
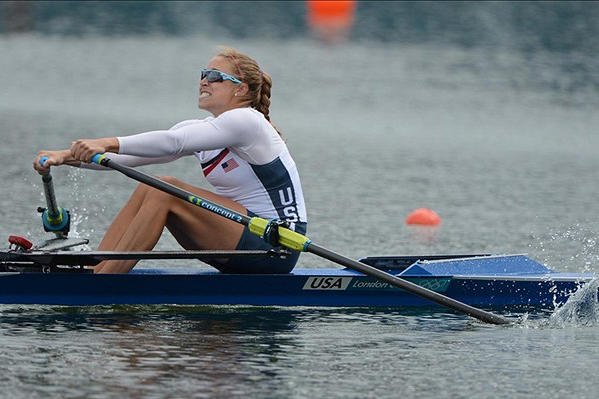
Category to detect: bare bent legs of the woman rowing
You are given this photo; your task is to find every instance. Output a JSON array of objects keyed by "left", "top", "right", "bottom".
[{"left": 94, "top": 178, "right": 247, "bottom": 273}]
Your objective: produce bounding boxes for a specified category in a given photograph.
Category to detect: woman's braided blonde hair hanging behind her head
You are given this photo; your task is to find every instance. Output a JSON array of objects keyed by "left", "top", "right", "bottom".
[{"left": 217, "top": 47, "right": 281, "bottom": 134}]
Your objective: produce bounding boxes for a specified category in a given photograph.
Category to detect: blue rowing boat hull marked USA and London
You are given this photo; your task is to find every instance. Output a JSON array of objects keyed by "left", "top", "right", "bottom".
[{"left": 0, "top": 256, "right": 593, "bottom": 309}]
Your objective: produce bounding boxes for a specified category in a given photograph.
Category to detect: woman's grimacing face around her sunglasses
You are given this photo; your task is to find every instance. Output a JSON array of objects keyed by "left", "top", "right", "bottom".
[{"left": 198, "top": 56, "right": 243, "bottom": 116}]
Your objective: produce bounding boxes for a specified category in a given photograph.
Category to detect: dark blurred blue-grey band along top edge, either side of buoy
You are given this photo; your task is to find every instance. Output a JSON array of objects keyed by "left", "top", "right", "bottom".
[{"left": 0, "top": 1, "right": 599, "bottom": 52}]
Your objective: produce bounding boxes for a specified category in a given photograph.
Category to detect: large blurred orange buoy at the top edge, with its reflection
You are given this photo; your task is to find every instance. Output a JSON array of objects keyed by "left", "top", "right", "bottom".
[{"left": 306, "top": 0, "right": 356, "bottom": 43}]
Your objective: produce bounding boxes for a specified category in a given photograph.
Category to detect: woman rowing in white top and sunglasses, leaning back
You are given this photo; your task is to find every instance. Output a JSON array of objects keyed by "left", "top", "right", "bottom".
[{"left": 33, "top": 48, "right": 307, "bottom": 273}]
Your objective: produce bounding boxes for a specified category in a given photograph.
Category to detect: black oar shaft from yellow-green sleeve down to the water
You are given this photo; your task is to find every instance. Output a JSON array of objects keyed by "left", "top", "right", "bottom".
[{"left": 307, "top": 242, "right": 511, "bottom": 324}]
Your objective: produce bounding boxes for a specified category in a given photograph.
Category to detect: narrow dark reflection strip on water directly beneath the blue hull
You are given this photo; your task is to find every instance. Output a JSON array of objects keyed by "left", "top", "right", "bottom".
[{"left": 0, "top": 305, "right": 478, "bottom": 336}]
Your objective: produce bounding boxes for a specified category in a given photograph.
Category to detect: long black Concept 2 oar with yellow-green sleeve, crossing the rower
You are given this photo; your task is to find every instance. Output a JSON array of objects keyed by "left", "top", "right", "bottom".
[{"left": 92, "top": 154, "right": 511, "bottom": 324}]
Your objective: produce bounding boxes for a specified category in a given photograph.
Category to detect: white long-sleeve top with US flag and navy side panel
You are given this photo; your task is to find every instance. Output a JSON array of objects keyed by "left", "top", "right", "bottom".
[{"left": 84, "top": 108, "right": 307, "bottom": 230}]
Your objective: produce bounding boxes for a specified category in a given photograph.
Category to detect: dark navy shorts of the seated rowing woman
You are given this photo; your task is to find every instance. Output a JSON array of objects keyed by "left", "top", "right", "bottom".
[{"left": 207, "top": 216, "right": 307, "bottom": 274}]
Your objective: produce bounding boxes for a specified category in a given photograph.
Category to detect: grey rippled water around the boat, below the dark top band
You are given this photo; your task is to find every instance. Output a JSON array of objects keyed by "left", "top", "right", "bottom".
[{"left": 0, "top": 7, "right": 599, "bottom": 398}]
